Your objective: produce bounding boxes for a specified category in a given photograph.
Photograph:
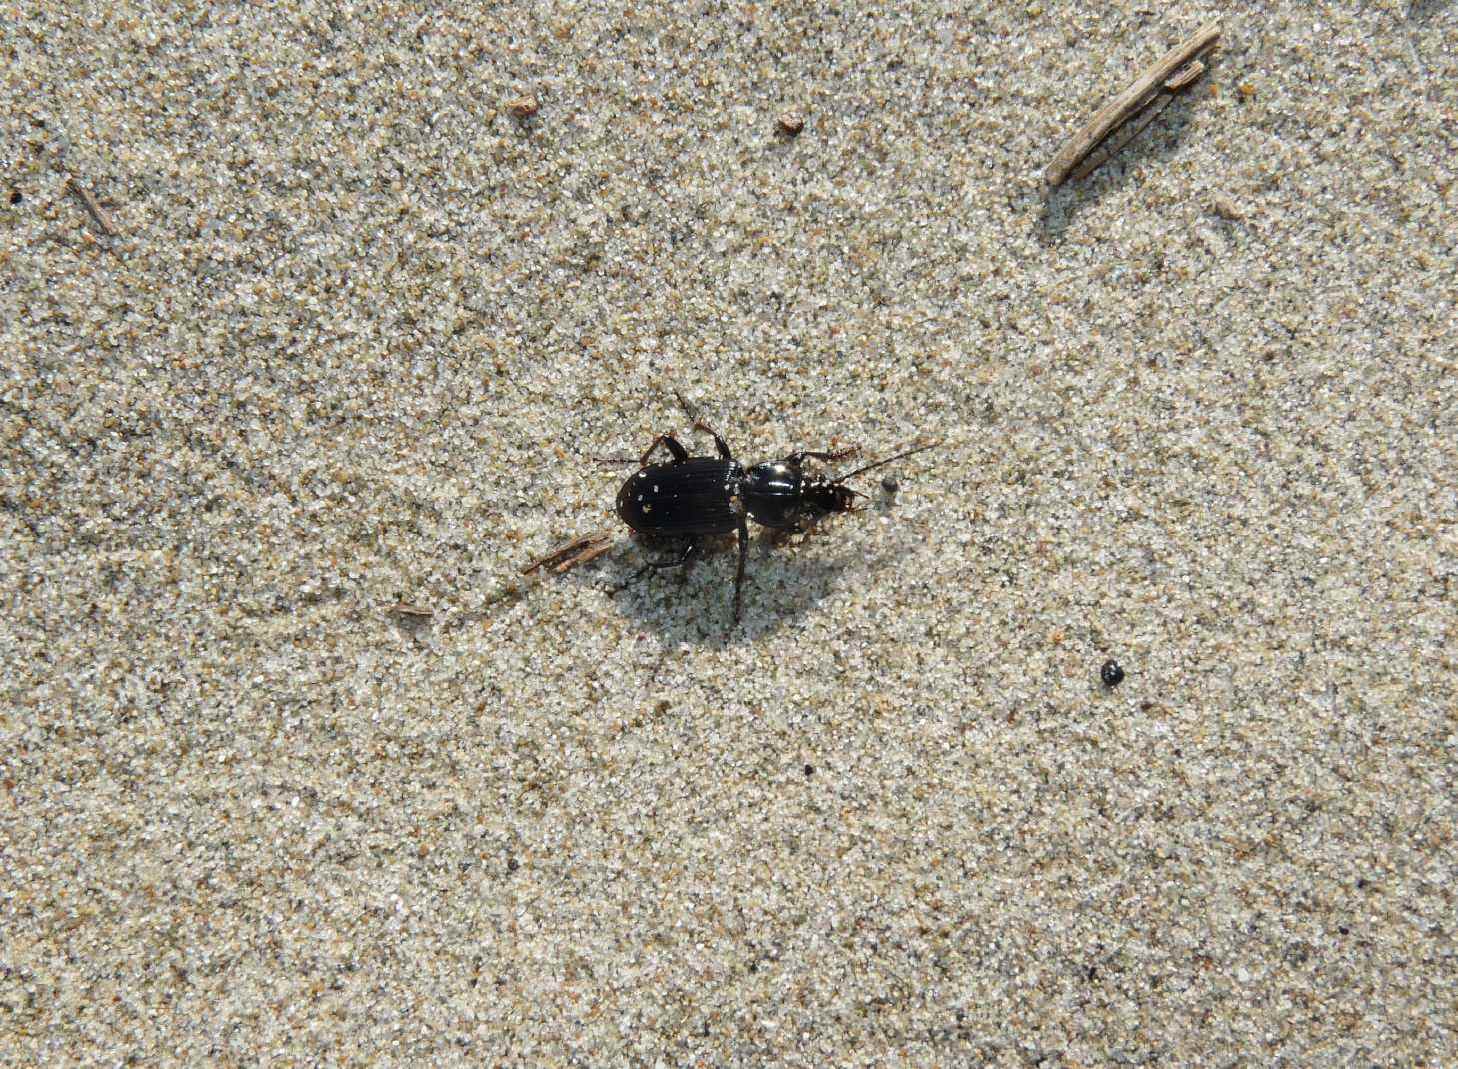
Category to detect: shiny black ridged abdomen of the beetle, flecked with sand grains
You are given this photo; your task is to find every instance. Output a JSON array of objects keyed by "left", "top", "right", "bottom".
[{"left": 618, "top": 456, "right": 744, "bottom": 535}]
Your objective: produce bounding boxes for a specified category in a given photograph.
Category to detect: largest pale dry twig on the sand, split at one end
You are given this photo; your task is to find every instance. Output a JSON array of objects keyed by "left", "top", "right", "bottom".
[{"left": 1044, "top": 22, "right": 1220, "bottom": 188}]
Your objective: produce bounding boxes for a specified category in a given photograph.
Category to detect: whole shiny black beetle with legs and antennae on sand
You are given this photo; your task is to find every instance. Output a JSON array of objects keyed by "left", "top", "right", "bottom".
[{"left": 617, "top": 423, "right": 939, "bottom": 623}]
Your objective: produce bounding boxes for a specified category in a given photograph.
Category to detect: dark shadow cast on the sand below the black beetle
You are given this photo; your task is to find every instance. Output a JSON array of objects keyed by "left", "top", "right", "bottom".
[{"left": 598, "top": 531, "right": 853, "bottom": 649}]
